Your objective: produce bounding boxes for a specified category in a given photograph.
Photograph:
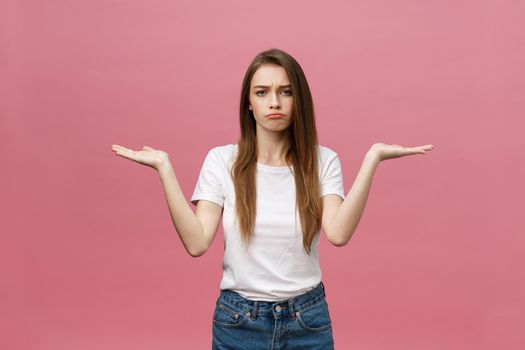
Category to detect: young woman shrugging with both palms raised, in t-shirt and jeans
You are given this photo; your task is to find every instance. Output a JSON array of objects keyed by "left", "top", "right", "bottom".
[{"left": 113, "top": 49, "right": 433, "bottom": 350}]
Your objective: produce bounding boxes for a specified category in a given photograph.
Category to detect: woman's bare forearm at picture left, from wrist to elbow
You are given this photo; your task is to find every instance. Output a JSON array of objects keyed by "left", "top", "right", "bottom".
[{"left": 158, "top": 163, "right": 205, "bottom": 256}]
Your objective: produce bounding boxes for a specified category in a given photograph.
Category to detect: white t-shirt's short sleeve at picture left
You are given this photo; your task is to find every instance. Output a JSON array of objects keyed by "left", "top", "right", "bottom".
[{"left": 191, "top": 148, "right": 224, "bottom": 207}]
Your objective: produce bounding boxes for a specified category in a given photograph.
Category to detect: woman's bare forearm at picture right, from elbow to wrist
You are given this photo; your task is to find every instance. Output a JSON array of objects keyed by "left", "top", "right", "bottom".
[{"left": 331, "top": 152, "right": 380, "bottom": 246}]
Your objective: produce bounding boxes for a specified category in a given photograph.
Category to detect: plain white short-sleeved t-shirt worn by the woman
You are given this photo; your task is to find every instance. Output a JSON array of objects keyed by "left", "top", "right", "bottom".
[{"left": 191, "top": 144, "right": 345, "bottom": 301}]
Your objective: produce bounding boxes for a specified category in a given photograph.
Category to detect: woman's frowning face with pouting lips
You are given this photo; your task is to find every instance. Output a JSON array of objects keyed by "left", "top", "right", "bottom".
[{"left": 250, "top": 64, "right": 293, "bottom": 132}]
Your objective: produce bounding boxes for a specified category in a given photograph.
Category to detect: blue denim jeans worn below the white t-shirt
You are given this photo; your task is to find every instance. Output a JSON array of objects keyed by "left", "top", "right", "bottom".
[{"left": 212, "top": 282, "right": 334, "bottom": 350}]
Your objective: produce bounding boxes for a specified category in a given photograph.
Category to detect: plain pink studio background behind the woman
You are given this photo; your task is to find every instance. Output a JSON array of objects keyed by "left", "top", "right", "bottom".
[{"left": 0, "top": 0, "right": 525, "bottom": 350}]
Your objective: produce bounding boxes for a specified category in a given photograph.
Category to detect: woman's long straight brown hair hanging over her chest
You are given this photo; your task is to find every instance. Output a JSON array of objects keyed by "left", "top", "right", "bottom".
[{"left": 231, "top": 48, "right": 322, "bottom": 254}]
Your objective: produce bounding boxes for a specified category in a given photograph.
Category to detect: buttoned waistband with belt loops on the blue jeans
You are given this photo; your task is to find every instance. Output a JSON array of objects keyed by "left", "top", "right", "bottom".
[{"left": 217, "top": 281, "right": 326, "bottom": 319}]
